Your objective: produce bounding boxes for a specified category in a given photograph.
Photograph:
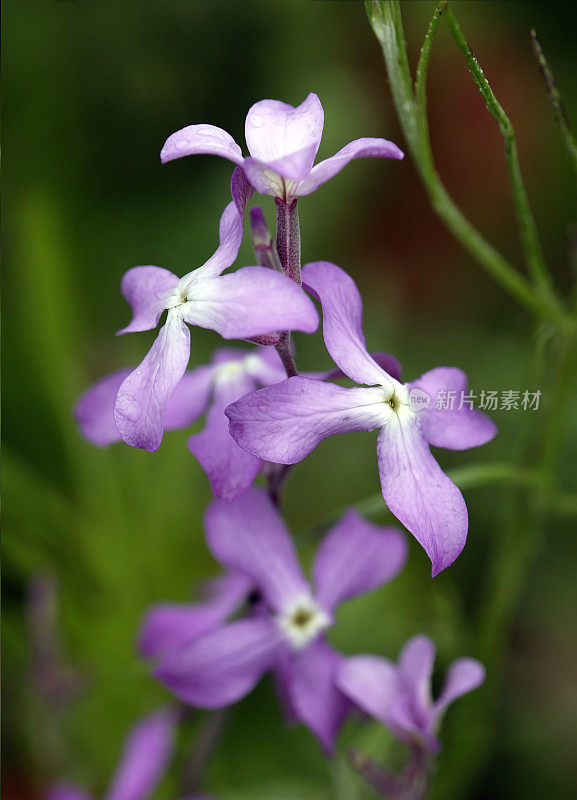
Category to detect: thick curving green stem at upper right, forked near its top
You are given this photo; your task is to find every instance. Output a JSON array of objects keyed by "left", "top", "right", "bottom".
[{"left": 366, "top": 0, "right": 567, "bottom": 326}]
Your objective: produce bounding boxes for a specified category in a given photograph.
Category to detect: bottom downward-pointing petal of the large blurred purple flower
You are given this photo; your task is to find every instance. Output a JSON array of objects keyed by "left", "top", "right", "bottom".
[{"left": 287, "top": 639, "right": 350, "bottom": 755}]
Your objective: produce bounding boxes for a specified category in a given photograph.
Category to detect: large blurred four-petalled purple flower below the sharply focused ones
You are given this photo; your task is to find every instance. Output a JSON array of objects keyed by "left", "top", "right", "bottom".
[{"left": 155, "top": 488, "right": 406, "bottom": 752}]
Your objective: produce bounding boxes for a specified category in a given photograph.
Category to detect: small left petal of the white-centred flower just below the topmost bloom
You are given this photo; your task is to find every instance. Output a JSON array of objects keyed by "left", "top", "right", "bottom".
[{"left": 118, "top": 267, "right": 179, "bottom": 334}]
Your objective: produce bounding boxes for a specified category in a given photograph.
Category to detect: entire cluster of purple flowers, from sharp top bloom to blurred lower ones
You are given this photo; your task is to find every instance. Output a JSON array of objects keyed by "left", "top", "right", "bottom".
[{"left": 65, "top": 94, "right": 496, "bottom": 800}]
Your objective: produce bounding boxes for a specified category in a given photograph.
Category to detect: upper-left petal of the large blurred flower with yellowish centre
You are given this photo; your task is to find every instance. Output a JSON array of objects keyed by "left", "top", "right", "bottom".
[{"left": 205, "top": 487, "right": 310, "bottom": 610}]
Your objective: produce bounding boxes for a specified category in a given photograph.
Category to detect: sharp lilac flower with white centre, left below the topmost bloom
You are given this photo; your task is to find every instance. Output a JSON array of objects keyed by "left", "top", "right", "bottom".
[{"left": 114, "top": 177, "right": 318, "bottom": 452}]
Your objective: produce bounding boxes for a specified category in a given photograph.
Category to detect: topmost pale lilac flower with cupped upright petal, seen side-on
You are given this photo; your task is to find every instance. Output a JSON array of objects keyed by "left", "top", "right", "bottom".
[{"left": 160, "top": 94, "right": 403, "bottom": 202}]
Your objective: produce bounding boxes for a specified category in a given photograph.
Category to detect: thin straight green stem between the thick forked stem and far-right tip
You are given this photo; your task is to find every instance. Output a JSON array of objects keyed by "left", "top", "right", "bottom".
[{"left": 445, "top": 8, "right": 554, "bottom": 302}]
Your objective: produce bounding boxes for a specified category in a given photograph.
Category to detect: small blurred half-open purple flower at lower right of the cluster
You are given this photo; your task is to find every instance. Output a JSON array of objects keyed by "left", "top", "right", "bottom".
[{"left": 337, "top": 636, "right": 485, "bottom": 753}]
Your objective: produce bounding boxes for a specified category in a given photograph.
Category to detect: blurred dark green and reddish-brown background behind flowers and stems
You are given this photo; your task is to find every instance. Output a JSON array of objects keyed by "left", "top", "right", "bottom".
[{"left": 4, "top": 0, "right": 577, "bottom": 800}]
